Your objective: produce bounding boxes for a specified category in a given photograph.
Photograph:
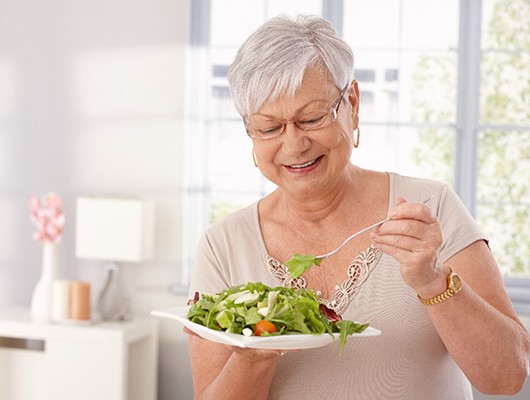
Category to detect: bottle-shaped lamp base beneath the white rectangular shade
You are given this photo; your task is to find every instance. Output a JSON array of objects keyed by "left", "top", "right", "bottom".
[{"left": 98, "top": 262, "right": 129, "bottom": 321}]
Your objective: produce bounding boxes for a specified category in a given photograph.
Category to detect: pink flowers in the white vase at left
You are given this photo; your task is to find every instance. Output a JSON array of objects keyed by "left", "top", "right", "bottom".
[{"left": 29, "top": 193, "right": 65, "bottom": 243}]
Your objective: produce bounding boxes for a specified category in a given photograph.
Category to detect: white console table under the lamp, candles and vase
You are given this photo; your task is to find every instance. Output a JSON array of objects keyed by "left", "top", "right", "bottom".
[{"left": 0, "top": 309, "right": 158, "bottom": 400}]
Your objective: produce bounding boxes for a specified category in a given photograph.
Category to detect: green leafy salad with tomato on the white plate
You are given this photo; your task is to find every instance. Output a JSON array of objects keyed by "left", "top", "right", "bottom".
[{"left": 187, "top": 282, "right": 368, "bottom": 349}]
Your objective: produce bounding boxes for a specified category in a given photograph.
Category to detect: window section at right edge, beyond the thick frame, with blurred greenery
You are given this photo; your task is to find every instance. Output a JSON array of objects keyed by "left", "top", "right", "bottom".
[{"left": 476, "top": 0, "right": 530, "bottom": 276}]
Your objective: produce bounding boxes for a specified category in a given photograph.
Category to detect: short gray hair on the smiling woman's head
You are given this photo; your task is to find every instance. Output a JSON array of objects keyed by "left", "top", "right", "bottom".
[{"left": 228, "top": 15, "right": 353, "bottom": 117}]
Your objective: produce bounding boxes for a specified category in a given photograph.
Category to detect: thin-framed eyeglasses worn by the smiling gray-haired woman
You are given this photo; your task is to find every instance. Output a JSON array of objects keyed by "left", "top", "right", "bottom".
[{"left": 245, "top": 86, "right": 348, "bottom": 139}]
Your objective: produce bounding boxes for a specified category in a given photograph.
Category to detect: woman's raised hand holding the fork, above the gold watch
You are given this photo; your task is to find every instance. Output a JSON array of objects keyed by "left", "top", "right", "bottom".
[{"left": 370, "top": 198, "right": 449, "bottom": 298}]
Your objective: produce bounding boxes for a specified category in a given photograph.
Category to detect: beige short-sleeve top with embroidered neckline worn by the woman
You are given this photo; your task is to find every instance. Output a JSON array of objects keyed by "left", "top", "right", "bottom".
[{"left": 190, "top": 173, "right": 485, "bottom": 400}]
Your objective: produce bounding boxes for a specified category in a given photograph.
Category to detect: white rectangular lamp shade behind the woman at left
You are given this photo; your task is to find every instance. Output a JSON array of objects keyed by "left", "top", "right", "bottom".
[{"left": 75, "top": 197, "right": 154, "bottom": 262}]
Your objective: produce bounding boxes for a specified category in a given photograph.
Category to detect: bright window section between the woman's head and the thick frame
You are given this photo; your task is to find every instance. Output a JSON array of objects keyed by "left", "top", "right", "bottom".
[{"left": 343, "top": 0, "right": 459, "bottom": 184}]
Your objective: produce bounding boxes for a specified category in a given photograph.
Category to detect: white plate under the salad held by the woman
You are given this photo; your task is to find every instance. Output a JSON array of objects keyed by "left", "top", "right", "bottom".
[{"left": 151, "top": 306, "right": 381, "bottom": 350}]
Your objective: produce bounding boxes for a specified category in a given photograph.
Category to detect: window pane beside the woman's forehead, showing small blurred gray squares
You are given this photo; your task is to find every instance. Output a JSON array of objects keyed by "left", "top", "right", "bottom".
[{"left": 353, "top": 48, "right": 457, "bottom": 124}]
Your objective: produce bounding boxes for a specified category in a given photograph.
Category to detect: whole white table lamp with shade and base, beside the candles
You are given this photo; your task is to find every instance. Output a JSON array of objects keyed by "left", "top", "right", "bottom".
[{"left": 75, "top": 197, "right": 154, "bottom": 320}]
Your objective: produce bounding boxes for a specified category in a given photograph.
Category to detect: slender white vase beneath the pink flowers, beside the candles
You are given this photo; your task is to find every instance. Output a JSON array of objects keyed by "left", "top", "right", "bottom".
[{"left": 31, "top": 242, "right": 58, "bottom": 322}]
